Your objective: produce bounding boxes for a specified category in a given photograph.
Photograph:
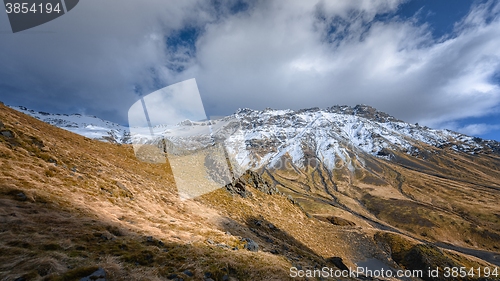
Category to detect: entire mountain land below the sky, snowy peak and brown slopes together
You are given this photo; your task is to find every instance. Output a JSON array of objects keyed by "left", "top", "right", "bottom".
[{"left": 0, "top": 101, "right": 500, "bottom": 280}]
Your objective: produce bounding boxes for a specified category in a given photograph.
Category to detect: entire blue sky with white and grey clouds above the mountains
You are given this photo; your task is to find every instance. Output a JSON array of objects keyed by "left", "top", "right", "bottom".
[{"left": 0, "top": 0, "right": 500, "bottom": 140}]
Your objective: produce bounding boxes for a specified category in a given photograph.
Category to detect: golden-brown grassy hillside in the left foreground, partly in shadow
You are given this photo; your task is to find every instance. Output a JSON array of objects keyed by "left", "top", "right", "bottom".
[{"left": 0, "top": 105, "right": 296, "bottom": 280}]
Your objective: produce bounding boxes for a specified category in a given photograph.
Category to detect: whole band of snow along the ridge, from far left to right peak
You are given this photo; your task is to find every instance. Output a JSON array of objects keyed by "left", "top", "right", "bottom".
[{"left": 13, "top": 105, "right": 500, "bottom": 168}]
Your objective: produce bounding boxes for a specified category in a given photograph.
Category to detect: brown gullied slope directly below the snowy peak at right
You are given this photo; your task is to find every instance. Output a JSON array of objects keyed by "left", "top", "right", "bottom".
[{"left": 263, "top": 132, "right": 500, "bottom": 264}]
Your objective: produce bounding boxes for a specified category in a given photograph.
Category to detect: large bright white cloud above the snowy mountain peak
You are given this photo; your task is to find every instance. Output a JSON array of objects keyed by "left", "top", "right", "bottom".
[{"left": 186, "top": 1, "right": 500, "bottom": 129}]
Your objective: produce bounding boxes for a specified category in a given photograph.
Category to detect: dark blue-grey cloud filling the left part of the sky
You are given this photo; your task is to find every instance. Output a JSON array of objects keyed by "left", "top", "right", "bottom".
[{"left": 0, "top": 0, "right": 210, "bottom": 123}]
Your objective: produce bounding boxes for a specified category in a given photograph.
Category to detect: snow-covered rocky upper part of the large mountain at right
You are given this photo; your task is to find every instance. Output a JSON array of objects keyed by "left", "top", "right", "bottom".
[{"left": 226, "top": 105, "right": 500, "bottom": 169}]
